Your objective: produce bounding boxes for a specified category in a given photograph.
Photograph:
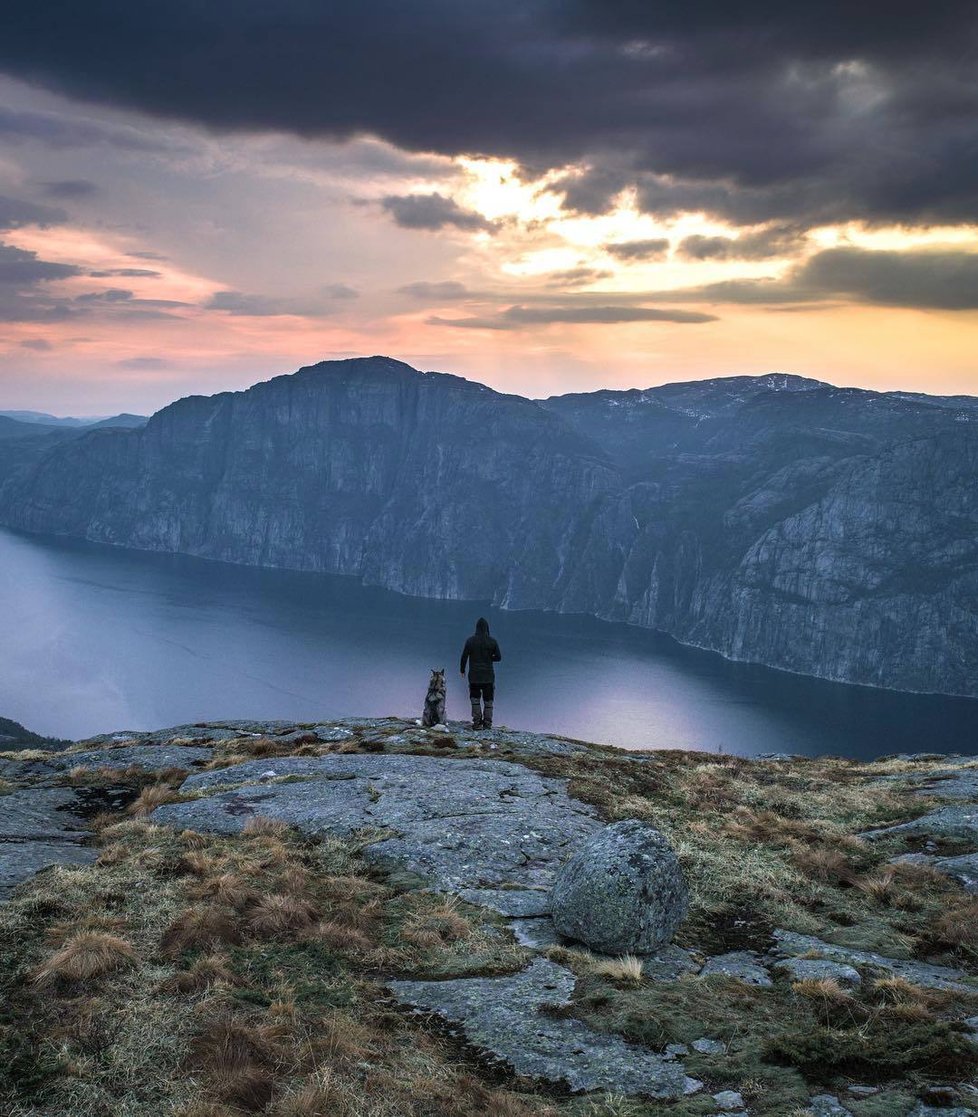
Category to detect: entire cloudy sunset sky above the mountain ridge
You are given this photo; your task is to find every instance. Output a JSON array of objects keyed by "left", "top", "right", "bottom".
[{"left": 0, "top": 0, "right": 978, "bottom": 414}]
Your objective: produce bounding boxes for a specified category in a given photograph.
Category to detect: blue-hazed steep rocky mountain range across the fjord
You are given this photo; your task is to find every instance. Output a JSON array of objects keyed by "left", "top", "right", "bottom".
[{"left": 0, "top": 357, "right": 978, "bottom": 695}]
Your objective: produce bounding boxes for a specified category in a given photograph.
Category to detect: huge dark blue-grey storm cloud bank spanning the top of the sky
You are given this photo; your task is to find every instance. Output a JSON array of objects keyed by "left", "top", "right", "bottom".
[{"left": 0, "top": 0, "right": 978, "bottom": 225}]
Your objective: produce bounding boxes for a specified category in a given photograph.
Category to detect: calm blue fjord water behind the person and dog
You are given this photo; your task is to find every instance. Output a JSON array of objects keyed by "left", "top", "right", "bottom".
[{"left": 0, "top": 532, "right": 978, "bottom": 757}]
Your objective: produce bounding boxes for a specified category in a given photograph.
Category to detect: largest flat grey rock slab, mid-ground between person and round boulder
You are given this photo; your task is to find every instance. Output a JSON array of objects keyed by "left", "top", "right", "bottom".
[{"left": 153, "top": 753, "right": 601, "bottom": 891}]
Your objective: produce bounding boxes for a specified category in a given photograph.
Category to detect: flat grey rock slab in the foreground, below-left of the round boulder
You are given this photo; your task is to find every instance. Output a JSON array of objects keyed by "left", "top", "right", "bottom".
[{"left": 389, "top": 958, "right": 702, "bottom": 1099}]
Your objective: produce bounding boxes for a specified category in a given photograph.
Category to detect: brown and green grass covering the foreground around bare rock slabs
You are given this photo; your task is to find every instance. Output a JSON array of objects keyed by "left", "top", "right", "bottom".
[{"left": 0, "top": 723, "right": 978, "bottom": 1117}]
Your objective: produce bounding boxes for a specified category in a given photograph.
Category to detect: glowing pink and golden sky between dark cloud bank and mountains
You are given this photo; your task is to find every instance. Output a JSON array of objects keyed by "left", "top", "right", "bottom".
[{"left": 0, "top": 16, "right": 978, "bottom": 412}]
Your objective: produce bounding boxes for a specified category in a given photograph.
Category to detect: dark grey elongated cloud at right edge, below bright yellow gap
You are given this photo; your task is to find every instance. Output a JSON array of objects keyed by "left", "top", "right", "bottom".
[{"left": 648, "top": 248, "right": 978, "bottom": 311}]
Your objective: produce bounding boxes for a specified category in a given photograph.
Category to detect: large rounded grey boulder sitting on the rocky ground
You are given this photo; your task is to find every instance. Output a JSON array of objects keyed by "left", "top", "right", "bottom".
[{"left": 550, "top": 819, "right": 689, "bottom": 954}]
